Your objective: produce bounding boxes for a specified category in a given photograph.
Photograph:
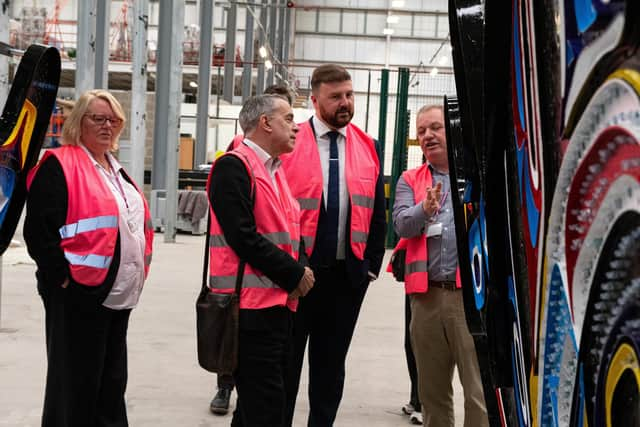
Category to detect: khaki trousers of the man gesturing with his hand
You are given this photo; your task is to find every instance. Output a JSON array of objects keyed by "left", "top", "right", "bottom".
[{"left": 409, "top": 288, "right": 489, "bottom": 427}]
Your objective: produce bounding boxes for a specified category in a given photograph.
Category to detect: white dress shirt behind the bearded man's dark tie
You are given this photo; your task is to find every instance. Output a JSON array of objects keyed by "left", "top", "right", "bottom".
[{"left": 313, "top": 116, "right": 349, "bottom": 259}]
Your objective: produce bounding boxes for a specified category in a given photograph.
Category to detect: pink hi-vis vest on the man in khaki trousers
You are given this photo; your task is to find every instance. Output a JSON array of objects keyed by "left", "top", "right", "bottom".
[{"left": 394, "top": 163, "right": 461, "bottom": 294}]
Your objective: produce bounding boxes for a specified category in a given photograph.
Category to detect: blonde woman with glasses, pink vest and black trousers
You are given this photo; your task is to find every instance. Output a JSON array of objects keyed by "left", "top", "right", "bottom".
[{"left": 24, "top": 90, "right": 153, "bottom": 427}]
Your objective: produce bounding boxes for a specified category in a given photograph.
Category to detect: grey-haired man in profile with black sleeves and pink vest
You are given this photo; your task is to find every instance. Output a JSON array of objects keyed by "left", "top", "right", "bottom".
[{"left": 208, "top": 95, "right": 314, "bottom": 427}]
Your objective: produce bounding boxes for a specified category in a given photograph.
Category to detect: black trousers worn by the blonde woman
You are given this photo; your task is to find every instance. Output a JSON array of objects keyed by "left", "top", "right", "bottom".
[{"left": 39, "top": 283, "right": 131, "bottom": 427}]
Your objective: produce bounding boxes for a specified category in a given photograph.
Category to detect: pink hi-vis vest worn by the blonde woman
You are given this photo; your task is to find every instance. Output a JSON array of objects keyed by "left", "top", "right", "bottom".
[{"left": 27, "top": 145, "right": 153, "bottom": 286}]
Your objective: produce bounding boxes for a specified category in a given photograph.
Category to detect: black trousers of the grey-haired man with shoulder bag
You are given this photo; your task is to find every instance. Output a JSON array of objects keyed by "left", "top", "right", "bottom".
[{"left": 231, "top": 307, "right": 293, "bottom": 427}]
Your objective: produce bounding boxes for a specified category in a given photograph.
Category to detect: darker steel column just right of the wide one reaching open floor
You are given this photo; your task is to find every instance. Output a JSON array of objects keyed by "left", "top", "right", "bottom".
[{"left": 194, "top": 0, "right": 213, "bottom": 166}]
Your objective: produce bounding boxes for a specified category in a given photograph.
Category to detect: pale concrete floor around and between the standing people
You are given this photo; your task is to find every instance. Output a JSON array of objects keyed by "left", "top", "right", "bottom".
[{"left": 0, "top": 234, "right": 464, "bottom": 427}]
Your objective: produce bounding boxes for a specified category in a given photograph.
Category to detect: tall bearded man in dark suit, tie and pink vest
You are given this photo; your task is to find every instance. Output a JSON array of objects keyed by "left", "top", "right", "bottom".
[{"left": 282, "top": 64, "right": 386, "bottom": 427}]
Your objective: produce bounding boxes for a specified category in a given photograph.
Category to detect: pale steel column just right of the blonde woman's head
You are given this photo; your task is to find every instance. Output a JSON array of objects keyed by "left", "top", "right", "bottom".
[{"left": 129, "top": 0, "right": 149, "bottom": 186}]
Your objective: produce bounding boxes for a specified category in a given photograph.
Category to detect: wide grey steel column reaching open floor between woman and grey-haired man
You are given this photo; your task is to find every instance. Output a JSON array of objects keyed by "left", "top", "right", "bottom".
[{"left": 151, "top": 0, "right": 184, "bottom": 243}]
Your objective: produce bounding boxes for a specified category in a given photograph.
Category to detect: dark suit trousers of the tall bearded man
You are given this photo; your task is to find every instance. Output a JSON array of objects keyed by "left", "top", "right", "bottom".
[{"left": 286, "top": 267, "right": 368, "bottom": 427}]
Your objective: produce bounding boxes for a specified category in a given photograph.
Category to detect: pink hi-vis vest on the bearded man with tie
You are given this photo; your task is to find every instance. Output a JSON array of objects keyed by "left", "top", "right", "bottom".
[{"left": 282, "top": 121, "right": 380, "bottom": 260}]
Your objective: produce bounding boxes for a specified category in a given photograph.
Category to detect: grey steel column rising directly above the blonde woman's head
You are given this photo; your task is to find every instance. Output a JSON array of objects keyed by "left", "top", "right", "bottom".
[{"left": 75, "top": 0, "right": 96, "bottom": 99}]
